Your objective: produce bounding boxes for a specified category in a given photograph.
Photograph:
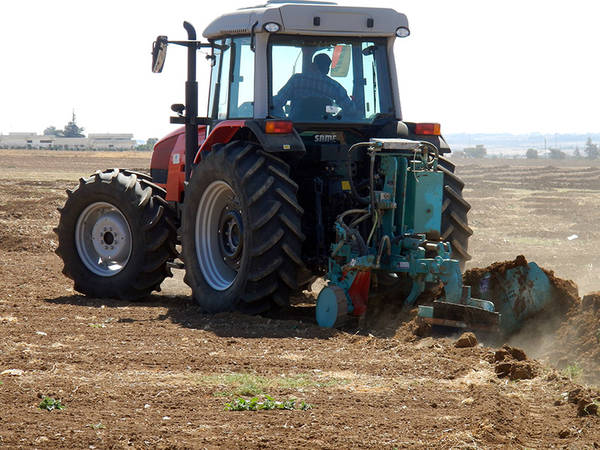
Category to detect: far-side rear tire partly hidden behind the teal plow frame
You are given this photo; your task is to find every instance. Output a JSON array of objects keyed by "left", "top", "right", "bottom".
[{"left": 438, "top": 157, "right": 473, "bottom": 270}]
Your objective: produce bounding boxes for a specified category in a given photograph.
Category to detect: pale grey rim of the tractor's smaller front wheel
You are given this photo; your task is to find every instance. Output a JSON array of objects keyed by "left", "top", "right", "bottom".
[{"left": 75, "top": 202, "right": 132, "bottom": 277}]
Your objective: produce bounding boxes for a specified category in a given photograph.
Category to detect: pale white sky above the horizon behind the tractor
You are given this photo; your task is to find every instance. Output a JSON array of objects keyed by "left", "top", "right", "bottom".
[{"left": 0, "top": 0, "right": 600, "bottom": 140}]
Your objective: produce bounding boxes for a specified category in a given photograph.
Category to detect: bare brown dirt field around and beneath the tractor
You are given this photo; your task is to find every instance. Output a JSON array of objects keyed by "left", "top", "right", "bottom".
[{"left": 0, "top": 150, "right": 600, "bottom": 448}]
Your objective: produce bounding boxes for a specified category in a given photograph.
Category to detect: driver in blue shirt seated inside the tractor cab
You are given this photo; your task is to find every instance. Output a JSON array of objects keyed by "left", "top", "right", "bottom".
[{"left": 273, "top": 53, "right": 352, "bottom": 116}]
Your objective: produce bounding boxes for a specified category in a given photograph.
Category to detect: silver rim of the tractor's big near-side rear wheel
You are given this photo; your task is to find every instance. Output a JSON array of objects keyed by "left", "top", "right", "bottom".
[{"left": 195, "top": 181, "right": 244, "bottom": 291}]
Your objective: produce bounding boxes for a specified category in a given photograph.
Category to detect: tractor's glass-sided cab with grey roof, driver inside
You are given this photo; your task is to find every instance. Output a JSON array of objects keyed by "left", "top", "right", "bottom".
[{"left": 203, "top": 0, "right": 409, "bottom": 125}]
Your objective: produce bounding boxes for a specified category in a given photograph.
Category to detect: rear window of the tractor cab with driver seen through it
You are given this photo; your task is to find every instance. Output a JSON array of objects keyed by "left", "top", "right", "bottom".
[{"left": 269, "top": 34, "right": 394, "bottom": 123}]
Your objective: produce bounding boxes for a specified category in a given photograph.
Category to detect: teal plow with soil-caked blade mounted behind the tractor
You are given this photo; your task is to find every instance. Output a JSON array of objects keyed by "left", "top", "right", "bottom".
[{"left": 316, "top": 139, "right": 556, "bottom": 334}]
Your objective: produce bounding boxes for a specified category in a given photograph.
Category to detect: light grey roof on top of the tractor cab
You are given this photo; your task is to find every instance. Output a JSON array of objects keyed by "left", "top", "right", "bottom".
[{"left": 202, "top": 0, "right": 408, "bottom": 39}]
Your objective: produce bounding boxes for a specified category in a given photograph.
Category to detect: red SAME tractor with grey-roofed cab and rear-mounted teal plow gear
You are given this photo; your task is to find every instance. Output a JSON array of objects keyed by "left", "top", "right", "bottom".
[{"left": 57, "top": 0, "right": 556, "bottom": 327}]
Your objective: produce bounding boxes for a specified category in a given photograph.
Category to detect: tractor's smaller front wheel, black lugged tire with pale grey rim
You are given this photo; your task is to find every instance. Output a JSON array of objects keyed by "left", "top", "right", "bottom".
[{"left": 54, "top": 169, "right": 177, "bottom": 300}]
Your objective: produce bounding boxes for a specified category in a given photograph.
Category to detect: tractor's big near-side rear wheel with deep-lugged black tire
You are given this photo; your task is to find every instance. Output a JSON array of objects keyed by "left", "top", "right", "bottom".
[{"left": 181, "top": 141, "right": 304, "bottom": 314}]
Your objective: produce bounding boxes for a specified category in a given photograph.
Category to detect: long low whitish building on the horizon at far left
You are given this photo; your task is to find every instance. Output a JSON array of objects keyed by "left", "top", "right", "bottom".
[{"left": 0, "top": 132, "right": 136, "bottom": 150}]
